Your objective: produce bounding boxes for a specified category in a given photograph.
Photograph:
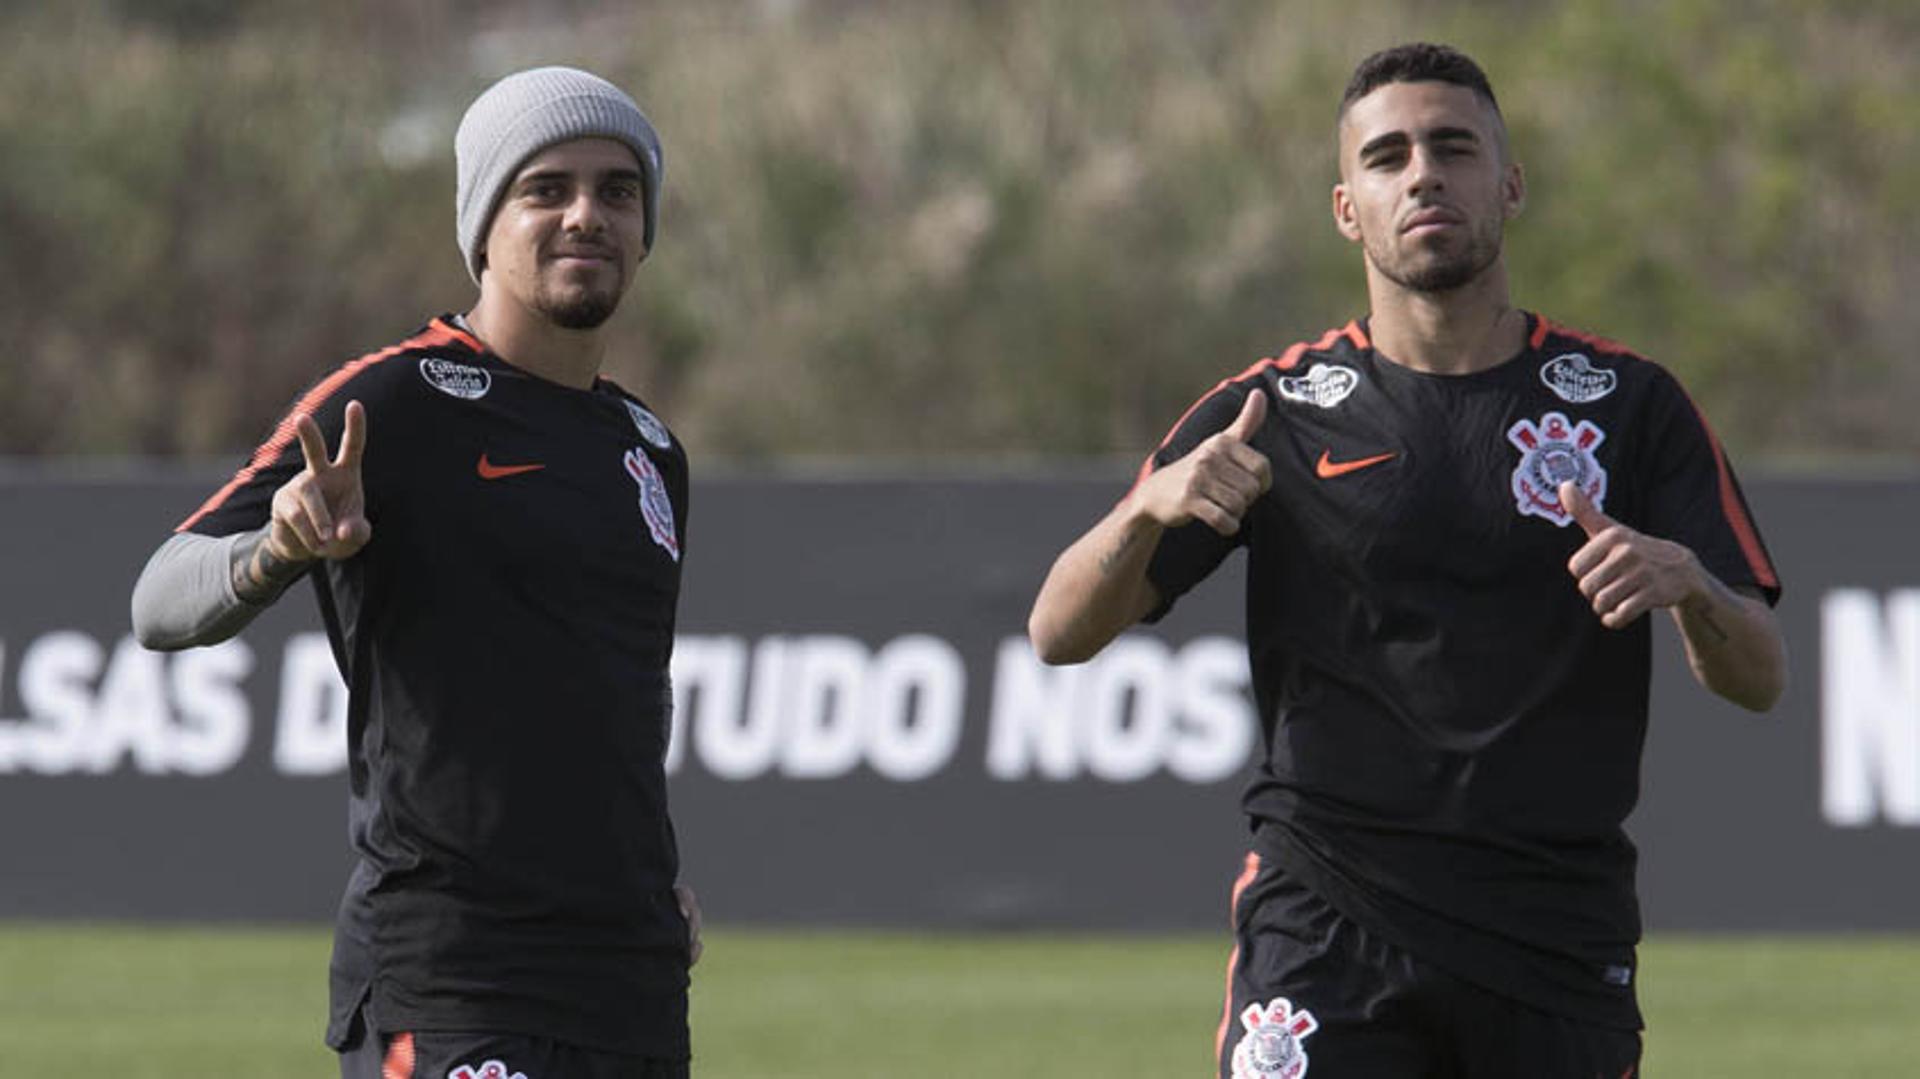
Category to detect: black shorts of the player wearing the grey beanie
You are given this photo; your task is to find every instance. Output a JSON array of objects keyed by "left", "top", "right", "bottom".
[{"left": 340, "top": 1010, "right": 689, "bottom": 1079}]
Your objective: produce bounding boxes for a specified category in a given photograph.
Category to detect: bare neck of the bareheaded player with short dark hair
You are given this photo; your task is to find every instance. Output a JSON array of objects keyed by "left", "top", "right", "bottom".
[{"left": 1367, "top": 261, "right": 1526, "bottom": 374}]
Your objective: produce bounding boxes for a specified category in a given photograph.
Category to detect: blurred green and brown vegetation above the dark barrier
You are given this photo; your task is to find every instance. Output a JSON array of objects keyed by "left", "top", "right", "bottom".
[{"left": 0, "top": 0, "right": 1920, "bottom": 467}]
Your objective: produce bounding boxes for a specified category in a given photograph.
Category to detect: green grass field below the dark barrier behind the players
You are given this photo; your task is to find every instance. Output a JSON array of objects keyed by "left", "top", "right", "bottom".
[{"left": 0, "top": 925, "right": 1920, "bottom": 1079}]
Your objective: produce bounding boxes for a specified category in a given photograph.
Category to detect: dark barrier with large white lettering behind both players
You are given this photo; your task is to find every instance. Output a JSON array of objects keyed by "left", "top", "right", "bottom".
[{"left": 0, "top": 470, "right": 1920, "bottom": 929}]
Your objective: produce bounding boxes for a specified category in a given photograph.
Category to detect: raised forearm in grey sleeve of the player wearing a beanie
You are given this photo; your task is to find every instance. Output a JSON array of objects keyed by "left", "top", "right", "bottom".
[{"left": 132, "top": 530, "right": 305, "bottom": 651}]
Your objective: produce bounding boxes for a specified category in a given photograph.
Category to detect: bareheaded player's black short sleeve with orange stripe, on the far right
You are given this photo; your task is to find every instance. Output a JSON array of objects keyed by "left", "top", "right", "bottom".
[{"left": 1642, "top": 371, "right": 1780, "bottom": 605}]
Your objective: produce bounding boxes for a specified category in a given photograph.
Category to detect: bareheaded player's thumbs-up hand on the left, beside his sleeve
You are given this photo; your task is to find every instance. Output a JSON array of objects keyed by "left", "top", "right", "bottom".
[{"left": 1131, "top": 384, "right": 1273, "bottom": 536}]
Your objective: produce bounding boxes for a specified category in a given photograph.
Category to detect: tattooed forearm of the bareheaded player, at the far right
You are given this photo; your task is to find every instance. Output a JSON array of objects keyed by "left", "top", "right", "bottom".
[{"left": 1672, "top": 574, "right": 1788, "bottom": 712}]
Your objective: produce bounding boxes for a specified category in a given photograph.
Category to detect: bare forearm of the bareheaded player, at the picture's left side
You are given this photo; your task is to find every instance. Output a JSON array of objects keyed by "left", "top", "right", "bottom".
[{"left": 1027, "top": 497, "right": 1164, "bottom": 664}]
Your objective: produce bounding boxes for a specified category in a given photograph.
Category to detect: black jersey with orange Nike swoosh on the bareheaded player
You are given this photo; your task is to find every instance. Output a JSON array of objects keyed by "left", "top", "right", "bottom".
[{"left": 1142, "top": 315, "right": 1778, "bottom": 1025}]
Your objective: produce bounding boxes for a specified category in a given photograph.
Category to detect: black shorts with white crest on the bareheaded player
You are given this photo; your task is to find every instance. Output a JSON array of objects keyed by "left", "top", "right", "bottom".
[{"left": 1213, "top": 854, "right": 1640, "bottom": 1079}]
